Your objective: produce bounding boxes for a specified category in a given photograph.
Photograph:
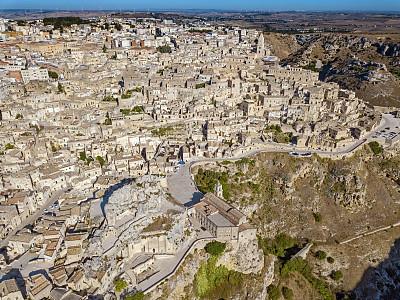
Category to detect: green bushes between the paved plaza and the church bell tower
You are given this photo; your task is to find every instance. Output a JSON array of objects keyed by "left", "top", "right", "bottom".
[{"left": 194, "top": 168, "right": 231, "bottom": 200}]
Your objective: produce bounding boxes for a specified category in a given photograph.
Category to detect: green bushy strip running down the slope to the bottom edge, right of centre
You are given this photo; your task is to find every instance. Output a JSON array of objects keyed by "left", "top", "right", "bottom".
[{"left": 280, "top": 257, "right": 334, "bottom": 300}]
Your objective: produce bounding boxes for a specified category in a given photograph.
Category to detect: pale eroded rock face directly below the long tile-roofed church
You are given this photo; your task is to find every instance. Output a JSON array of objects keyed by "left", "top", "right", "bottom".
[{"left": 217, "top": 238, "right": 264, "bottom": 274}]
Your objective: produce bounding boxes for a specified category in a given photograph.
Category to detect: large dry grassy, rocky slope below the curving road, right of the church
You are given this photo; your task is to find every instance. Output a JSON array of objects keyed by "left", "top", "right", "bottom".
[{"left": 177, "top": 146, "right": 400, "bottom": 299}]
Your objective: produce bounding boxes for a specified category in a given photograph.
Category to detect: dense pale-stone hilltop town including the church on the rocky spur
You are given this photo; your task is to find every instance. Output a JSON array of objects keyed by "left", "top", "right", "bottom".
[{"left": 0, "top": 17, "right": 400, "bottom": 299}]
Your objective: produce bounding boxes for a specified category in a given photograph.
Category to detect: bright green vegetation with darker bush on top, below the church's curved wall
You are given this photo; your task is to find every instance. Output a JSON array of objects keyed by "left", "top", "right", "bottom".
[{"left": 194, "top": 242, "right": 242, "bottom": 299}]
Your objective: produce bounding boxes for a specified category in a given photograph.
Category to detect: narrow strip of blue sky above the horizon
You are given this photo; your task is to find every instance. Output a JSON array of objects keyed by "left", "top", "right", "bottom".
[{"left": 0, "top": 0, "right": 400, "bottom": 11}]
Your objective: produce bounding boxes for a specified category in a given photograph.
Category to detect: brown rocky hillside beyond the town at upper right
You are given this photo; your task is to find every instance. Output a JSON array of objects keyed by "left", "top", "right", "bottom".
[{"left": 265, "top": 33, "right": 400, "bottom": 107}]
